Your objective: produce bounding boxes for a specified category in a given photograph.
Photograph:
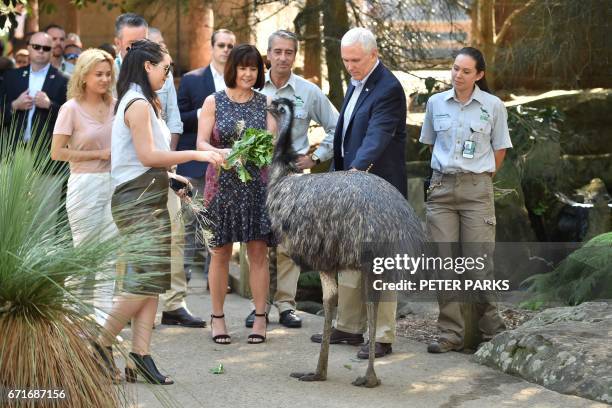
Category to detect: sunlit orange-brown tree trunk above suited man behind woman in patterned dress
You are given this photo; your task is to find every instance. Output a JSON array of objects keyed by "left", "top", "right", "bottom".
[{"left": 189, "top": 0, "right": 214, "bottom": 69}]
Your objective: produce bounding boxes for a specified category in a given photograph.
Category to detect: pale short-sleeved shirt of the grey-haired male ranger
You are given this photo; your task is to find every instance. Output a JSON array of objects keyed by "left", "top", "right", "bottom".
[{"left": 261, "top": 71, "right": 338, "bottom": 162}]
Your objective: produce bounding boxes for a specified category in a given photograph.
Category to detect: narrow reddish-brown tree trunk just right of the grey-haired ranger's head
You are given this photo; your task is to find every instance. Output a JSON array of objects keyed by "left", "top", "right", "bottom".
[{"left": 304, "top": 0, "right": 321, "bottom": 87}]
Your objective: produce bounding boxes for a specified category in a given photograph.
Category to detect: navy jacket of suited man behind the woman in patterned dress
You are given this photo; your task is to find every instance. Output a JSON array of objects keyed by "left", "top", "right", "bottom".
[{"left": 176, "top": 66, "right": 215, "bottom": 177}]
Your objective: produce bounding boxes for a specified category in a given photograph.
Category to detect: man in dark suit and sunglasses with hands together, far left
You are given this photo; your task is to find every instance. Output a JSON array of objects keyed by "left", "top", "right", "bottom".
[{"left": 0, "top": 32, "right": 68, "bottom": 147}]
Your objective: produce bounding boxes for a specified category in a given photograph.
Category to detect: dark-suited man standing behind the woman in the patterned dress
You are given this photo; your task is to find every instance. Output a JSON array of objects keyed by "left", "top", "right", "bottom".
[{"left": 176, "top": 29, "right": 236, "bottom": 288}]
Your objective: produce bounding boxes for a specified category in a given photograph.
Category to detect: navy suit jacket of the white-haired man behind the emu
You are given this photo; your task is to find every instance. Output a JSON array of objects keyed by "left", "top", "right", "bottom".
[{"left": 333, "top": 62, "right": 407, "bottom": 197}]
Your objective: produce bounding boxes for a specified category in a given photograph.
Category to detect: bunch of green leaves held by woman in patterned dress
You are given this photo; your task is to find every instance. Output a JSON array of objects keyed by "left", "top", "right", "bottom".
[{"left": 223, "top": 128, "right": 274, "bottom": 183}]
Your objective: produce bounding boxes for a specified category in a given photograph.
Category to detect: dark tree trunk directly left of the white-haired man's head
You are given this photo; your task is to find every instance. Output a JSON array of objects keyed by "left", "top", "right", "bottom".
[{"left": 323, "top": 0, "right": 348, "bottom": 110}]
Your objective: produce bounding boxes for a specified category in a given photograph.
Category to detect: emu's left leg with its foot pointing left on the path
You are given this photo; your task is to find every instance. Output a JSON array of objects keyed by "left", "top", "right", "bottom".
[{"left": 291, "top": 272, "right": 338, "bottom": 381}]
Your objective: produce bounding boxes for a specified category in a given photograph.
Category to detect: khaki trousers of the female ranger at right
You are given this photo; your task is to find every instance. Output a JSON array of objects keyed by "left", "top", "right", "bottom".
[{"left": 426, "top": 172, "right": 505, "bottom": 345}]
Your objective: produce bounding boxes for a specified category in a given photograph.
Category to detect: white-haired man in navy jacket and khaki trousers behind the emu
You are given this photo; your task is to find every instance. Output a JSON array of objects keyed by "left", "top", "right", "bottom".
[{"left": 312, "top": 28, "right": 407, "bottom": 359}]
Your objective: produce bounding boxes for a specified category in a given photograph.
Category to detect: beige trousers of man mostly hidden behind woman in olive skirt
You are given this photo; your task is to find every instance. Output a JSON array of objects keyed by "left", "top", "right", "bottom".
[{"left": 161, "top": 188, "right": 187, "bottom": 311}]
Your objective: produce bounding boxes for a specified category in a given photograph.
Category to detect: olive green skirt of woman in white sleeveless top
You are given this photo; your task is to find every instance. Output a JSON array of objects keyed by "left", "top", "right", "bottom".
[{"left": 111, "top": 169, "right": 171, "bottom": 295}]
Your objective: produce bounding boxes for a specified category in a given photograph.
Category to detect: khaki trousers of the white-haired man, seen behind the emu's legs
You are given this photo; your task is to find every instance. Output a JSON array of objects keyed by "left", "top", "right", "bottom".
[{"left": 336, "top": 270, "right": 397, "bottom": 343}]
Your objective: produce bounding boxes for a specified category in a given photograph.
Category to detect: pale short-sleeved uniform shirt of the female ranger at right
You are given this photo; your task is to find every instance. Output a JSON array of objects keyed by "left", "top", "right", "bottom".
[{"left": 419, "top": 85, "right": 512, "bottom": 174}]
